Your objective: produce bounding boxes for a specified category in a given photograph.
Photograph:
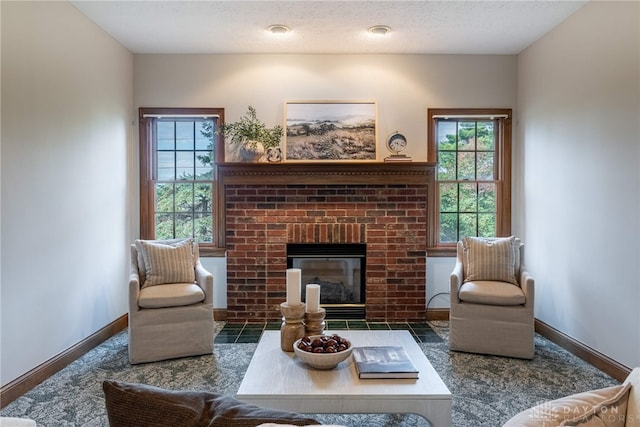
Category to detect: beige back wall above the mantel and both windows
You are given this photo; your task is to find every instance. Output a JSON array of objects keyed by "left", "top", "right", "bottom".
[{"left": 134, "top": 55, "right": 516, "bottom": 160}]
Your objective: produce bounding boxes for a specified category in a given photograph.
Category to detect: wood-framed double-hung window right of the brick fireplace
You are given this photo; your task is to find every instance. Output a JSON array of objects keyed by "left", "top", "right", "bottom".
[{"left": 428, "top": 109, "right": 511, "bottom": 254}]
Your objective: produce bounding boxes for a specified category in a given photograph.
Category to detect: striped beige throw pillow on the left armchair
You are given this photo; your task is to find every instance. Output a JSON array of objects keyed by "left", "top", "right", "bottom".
[{"left": 139, "top": 239, "right": 195, "bottom": 288}]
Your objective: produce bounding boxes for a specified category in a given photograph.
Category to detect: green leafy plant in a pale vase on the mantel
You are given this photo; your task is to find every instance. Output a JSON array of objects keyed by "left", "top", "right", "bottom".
[{"left": 218, "top": 105, "right": 283, "bottom": 160}]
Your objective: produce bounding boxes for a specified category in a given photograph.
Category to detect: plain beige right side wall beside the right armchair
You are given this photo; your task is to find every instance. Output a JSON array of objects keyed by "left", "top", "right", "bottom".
[{"left": 514, "top": 2, "right": 640, "bottom": 367}]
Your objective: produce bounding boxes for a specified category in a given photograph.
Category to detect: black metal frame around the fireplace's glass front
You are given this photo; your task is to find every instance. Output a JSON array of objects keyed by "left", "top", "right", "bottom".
[{"left": 287, "top": 243, "right": 367, "bottom": 319}]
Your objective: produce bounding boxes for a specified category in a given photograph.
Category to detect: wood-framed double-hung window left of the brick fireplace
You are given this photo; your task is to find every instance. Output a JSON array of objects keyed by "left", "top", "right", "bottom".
[{"left": 140, "top": 108, "right": 224, "bottom": 254}]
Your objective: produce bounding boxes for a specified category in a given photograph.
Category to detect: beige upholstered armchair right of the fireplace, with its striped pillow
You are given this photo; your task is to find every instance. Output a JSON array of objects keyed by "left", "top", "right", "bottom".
[{"left": 449, "top": 237, "right": 534, "bottom": 359}]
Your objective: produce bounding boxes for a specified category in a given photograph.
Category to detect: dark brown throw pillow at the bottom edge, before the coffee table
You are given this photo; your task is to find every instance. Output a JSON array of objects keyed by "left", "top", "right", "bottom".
[{"left": 102, "top": 380, "right": 319, "bottom": 427}]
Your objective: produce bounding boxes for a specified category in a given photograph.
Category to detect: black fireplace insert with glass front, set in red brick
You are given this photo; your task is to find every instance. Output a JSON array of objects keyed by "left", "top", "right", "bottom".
[{"left": 287, "top": 243, "right": 367, "bottom": 319}]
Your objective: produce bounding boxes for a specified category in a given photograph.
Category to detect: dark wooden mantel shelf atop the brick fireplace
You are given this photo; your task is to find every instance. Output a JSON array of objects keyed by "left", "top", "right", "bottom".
[{"left": 217, "top": 162, "right": 435, "bottom": 185}]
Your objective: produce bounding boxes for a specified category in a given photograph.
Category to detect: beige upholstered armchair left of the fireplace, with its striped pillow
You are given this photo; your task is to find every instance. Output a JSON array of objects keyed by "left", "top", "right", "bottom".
[{"left": 129, "top": 239, "right": 213, "bottom": 364}]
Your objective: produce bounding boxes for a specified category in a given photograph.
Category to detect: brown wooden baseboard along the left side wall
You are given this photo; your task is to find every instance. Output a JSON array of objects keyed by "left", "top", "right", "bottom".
[{"left": 0, "top": 314, "right": 129, "bottom": 409}]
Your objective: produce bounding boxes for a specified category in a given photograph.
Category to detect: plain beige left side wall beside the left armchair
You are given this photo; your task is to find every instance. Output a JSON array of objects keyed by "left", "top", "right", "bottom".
[{"left": 0, "top": 1, "right": 138, "bottom": 385}]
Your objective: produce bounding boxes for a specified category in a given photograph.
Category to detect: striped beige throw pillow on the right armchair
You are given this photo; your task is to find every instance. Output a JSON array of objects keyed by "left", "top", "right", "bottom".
[{"left": 462, "top": 236, "right": 519, "bottom": 285}]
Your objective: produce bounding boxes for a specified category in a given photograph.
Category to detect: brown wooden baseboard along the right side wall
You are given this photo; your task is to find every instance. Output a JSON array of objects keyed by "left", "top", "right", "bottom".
[{"left": 535, "top": 319, "right": 631, "bottom": 381}]
